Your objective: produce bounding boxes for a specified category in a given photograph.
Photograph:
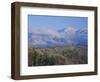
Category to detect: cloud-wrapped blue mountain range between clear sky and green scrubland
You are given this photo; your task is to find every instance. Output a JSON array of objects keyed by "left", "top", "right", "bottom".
[{"left": 28, "top": 27, "right": 87, "bottom": 48}]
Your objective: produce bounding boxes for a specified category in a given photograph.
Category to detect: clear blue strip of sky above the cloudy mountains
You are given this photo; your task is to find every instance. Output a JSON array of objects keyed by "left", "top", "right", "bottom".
[{"left": 28, "top": 15, "right": 88, "bottom": 31}]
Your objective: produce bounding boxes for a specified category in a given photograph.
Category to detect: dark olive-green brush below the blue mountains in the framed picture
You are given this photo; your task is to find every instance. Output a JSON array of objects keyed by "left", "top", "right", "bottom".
[{"left": 28, "top": 46, "right": 87, "bottom": 66}]
